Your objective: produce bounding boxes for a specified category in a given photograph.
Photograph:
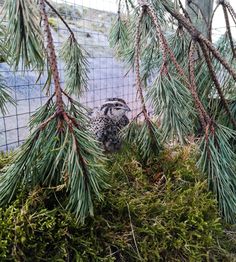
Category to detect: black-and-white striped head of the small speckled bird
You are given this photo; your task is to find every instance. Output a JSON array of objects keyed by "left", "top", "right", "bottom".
[{"left": 100, "top": 98, "right": 131, "bottom": 119}]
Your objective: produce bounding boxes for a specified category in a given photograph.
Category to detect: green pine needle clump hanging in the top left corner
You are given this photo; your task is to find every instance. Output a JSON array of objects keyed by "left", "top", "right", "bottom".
[{"left": 3, "top": 0, "right": 45, "bottom": 72}]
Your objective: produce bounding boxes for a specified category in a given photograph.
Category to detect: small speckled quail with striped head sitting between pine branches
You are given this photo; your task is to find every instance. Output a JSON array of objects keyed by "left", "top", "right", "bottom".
[{"left": 91, "top": 98, "right": 131, "bottom": 152}]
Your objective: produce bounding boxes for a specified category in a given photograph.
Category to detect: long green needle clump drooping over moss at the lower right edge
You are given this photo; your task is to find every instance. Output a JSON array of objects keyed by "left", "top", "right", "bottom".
[{"left": 198, "top": 126, "right": 236, "bottom": 223}]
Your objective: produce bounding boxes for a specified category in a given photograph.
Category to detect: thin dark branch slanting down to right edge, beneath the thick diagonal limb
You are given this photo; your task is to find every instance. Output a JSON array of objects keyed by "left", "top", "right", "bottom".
[{"left": 200, "top": 43, "right": 236, "bottom": 128}]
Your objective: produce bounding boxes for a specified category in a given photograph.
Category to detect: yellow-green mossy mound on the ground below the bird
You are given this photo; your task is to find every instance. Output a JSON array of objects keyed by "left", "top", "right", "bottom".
[{"left": 0, "top": 148, "right": 236, "bottom": 262}]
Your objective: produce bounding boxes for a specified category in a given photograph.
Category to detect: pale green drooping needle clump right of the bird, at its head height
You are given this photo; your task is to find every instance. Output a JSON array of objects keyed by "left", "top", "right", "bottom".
[{"left": 148, "top": 74, "right": 195, "bottom": 143}]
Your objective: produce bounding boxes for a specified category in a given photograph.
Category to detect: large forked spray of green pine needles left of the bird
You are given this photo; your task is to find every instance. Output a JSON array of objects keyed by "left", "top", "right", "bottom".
[{"left": 0, "top": 100, "right": 107, "bottom": 223}]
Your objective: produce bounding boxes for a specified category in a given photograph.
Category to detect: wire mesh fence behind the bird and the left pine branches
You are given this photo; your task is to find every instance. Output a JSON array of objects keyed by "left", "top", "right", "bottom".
[{"left": 0, "top": 0, "right": 139, "bottom": 151}]
